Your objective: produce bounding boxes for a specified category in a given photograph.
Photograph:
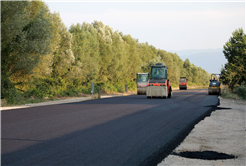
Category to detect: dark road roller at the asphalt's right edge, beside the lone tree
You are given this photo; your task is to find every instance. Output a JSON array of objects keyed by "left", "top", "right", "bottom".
[{"left": 208, "top": 73, "right": 221, "bottom": 95}]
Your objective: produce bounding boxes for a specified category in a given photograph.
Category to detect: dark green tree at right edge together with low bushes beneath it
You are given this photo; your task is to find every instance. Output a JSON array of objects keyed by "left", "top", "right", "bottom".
[{"left": 221, "top": 28, "right": 246, "bottom": 99}]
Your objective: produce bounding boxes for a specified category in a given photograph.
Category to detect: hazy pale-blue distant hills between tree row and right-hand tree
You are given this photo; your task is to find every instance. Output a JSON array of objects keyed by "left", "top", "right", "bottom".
[{"left": 169, "top": 48, "right": 227, "bottom": 73}]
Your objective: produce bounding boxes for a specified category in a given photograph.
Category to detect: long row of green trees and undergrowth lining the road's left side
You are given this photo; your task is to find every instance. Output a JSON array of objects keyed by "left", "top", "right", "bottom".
[{"left": 0, "top": 0, "right": 210, "bottom": 103}]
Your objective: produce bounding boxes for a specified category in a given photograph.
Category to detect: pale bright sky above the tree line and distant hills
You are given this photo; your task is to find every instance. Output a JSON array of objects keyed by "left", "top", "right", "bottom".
[{"left": 43, "top": 0, "right": 246, "bottom": 51}]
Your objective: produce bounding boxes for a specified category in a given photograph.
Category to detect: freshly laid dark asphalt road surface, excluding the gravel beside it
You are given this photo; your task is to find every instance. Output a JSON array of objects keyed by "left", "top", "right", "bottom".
[{"left": 0, "top": 90, "right": 218, "bottom": 166}]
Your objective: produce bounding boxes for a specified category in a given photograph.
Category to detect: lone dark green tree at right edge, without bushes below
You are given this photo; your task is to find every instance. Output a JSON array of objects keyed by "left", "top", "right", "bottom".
[{"left": 221, "top": 28, "right": 246, "bottom": 90}]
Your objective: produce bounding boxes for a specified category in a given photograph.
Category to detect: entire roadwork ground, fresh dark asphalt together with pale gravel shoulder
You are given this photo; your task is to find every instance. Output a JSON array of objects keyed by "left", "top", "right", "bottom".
[{"left": 0, "top": 90, "right": 246, "bottom": 166}]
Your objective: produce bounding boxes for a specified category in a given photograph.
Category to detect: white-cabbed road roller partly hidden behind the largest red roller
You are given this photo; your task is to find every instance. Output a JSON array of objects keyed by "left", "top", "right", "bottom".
[{"left": 136, "top": 73, "right": 149, "bottom": 95}]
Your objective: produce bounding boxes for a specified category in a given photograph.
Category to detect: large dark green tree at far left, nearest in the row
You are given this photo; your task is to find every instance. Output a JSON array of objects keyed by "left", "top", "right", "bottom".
[{"left": 0, "top": 0, "right": 52, "bottom": 99}]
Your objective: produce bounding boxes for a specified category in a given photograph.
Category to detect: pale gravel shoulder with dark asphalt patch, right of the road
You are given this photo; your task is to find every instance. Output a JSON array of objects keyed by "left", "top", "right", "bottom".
[{"left": 158, "top": 98, "right": 246, "bottom": 166}]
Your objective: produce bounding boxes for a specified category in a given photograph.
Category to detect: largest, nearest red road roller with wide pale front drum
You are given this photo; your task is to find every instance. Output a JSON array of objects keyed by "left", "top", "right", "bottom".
[{"left": 146, "top": 63, "right": 172, "bottom": 98}]
